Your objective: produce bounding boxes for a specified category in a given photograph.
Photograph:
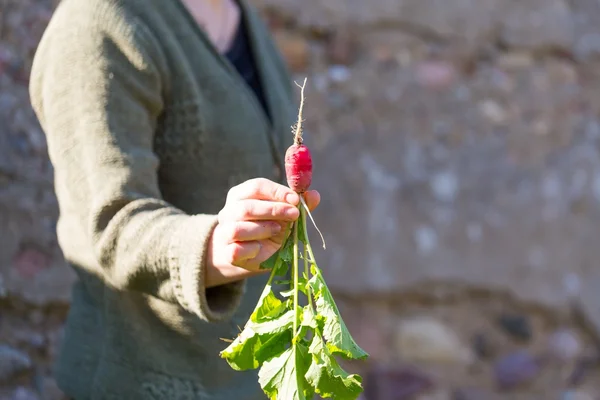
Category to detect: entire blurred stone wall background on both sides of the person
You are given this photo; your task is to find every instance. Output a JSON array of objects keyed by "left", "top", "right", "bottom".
[{"left": 0, "top": 0, "right": 600, "bottom": 400}]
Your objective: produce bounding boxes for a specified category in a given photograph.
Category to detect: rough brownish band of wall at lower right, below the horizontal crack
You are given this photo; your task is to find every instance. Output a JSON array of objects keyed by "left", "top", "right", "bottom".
[{"left": 338, "top": 294, "right": 600, "bottom": 400}]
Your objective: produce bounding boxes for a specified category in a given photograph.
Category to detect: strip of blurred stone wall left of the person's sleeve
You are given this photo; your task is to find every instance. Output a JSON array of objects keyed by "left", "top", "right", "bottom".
[{"left": 0, "top": 0, "right": 74, "bottom": 305}]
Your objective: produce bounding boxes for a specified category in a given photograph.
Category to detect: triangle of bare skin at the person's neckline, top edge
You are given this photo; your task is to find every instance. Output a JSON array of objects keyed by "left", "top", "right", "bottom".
[{"left": 182, "top": 0, "right": 240, "bottom": 53}]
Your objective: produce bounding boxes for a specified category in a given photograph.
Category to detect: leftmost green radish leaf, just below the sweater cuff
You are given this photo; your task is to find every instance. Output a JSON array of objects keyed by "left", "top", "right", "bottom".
[{"left": 220, "top": 310, "right": 295, "bottom": 371}]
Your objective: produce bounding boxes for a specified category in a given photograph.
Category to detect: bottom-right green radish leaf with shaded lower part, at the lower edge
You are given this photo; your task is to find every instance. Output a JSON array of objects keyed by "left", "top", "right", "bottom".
[{"left": 305, "top": 335, "right": 363, "bottom": 400}]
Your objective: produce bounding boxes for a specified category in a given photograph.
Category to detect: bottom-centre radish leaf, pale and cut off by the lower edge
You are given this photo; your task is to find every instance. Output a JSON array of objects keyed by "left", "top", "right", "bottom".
[{"left": 258, "top": 342, "right": 314, "bottom": 400}]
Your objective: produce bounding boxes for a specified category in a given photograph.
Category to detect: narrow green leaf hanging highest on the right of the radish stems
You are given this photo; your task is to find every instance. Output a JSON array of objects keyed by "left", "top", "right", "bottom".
[{"left": 308, "top": 264, "right": 369, "bottom": 360}]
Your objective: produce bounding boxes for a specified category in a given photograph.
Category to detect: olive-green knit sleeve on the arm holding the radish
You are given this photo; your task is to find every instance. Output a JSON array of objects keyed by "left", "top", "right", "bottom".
[{"left": 30, "top": 2, "right": 245, "bottom": 322}]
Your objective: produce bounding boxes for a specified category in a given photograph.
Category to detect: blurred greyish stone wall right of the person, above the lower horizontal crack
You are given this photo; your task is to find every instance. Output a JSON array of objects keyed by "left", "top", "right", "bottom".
[{"left": 266, "top": 0, "right": 600, "bottom": 322}]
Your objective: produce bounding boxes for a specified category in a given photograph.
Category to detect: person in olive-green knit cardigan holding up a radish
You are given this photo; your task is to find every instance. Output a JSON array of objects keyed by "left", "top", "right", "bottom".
[{"left": 29, "top": 0, "right": 320, "bottom": 400}]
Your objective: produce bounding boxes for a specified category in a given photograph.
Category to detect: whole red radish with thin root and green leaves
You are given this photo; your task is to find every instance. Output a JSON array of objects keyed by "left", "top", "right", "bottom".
[{"left": 220, "top": 79, "right": 368, "bottom": 400}]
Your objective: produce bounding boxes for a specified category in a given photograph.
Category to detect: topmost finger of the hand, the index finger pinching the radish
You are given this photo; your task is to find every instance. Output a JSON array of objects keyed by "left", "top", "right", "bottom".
[{"left": 227, "top": 178, "right": 300, "bottom": 205}]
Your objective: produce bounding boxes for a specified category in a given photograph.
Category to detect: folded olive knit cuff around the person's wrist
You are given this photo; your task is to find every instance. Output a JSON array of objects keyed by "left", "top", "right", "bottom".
[{"left": 169, "top": 214, "right": 246, "bottom": 322}]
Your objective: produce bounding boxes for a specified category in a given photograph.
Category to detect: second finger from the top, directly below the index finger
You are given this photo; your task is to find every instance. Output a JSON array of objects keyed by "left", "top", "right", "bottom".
[{"left": 219, "top": 199, "right": 300, "bottom": 223}]
